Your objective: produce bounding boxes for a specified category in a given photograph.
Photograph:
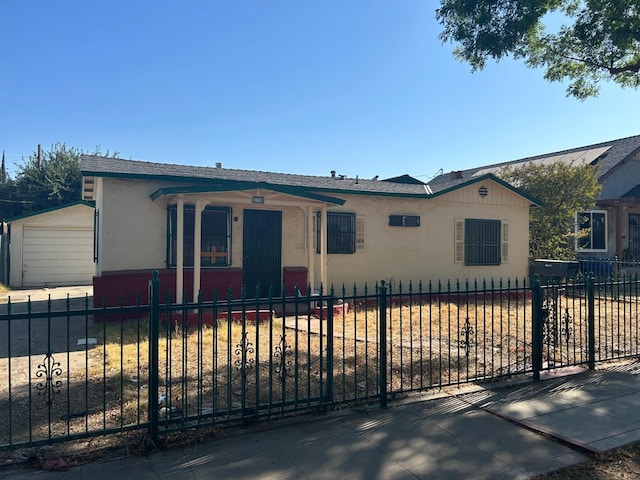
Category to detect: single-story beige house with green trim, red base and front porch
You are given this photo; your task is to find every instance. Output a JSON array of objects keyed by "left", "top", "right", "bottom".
[{"left": 81, "top": 155, "right": 535, "bottom": 305}]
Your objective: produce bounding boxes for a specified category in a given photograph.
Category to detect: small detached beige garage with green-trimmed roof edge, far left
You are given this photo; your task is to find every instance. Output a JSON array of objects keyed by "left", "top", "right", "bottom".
[{"left": 8, "top": 202, "right": 95, "bottom": 288}]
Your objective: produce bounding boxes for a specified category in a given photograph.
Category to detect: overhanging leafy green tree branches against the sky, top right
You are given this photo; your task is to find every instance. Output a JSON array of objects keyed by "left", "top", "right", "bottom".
[{"left": 436, "top": 0, "right": 640, "bottom": 99}]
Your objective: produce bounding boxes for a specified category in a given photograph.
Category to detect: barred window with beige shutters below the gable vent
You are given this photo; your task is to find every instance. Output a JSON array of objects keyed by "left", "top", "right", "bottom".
[{"left": 455, "top": 218, "right": 508, "bottom": 265}]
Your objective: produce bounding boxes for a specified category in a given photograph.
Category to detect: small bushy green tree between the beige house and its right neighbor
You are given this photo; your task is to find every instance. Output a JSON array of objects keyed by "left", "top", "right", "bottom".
[{"left": 497, "top": 162, "right": 601, "bottom": 260}]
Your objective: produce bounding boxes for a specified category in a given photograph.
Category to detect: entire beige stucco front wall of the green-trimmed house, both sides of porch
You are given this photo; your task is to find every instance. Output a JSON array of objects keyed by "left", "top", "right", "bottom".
[{"left": 98, "top": 178, "right": 529, "bottom": 288}]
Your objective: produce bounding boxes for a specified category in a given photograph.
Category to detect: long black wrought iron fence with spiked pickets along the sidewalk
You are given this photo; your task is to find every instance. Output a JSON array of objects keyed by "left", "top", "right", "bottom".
[{"left": 0, "top": 277, "right": 640, "bottom": 448}]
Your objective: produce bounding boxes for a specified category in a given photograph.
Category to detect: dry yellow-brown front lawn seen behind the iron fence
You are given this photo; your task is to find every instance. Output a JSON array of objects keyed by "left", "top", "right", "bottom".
[{"left": 0, "top": 290, "right": 638, "bottom": 466}]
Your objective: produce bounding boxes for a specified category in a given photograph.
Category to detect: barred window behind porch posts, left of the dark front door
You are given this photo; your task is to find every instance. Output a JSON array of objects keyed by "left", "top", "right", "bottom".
[{"left": 167, "top": 205, "right": 231, "bottom": 267}]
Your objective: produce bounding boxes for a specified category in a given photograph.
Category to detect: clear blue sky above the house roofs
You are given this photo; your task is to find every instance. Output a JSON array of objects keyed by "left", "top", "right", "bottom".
[{"left": 0, "top": 0, "right": 640, "bottom": 180}]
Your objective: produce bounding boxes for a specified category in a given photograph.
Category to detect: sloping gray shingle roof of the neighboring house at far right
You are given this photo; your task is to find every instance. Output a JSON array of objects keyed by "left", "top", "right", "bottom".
[{"left": 428, "top": 135, "right": 640, "bottom": 191}]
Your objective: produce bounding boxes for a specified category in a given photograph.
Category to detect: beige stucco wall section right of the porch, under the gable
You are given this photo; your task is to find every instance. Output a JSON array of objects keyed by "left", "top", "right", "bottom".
[{"left": 318, "top": 178, "right": 529, "bottom": 288}]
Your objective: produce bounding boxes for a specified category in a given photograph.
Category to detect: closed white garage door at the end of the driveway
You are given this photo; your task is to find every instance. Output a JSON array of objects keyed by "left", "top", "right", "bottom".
[{"left": 22, "top": 226, "right": 95, "bottom": 287}]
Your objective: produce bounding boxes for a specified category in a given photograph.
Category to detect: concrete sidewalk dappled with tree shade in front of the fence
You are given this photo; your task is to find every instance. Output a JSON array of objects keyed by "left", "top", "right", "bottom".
[{"left": 0, "top": 363, "right": 640, "bottom": 480}]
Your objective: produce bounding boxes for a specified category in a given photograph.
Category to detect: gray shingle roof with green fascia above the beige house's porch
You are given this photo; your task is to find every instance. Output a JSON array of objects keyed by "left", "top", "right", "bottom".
[{"left": 80, "top": 155, "right": 436, "bottom": 196}]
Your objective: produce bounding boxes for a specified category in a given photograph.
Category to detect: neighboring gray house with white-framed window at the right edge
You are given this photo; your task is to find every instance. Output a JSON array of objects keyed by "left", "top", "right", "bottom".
[{"left": 429, "top": 135, "right": 640, "bottom": 259}]
